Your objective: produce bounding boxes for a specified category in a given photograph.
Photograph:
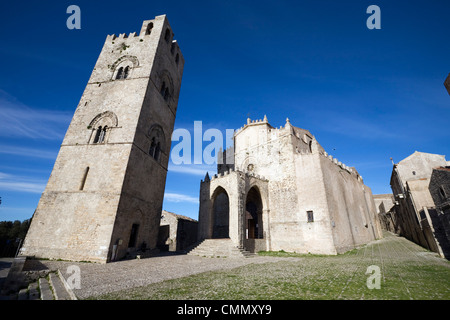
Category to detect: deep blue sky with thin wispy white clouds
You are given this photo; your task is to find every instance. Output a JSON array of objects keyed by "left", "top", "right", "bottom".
[{"left": 0, "top": 0, "right": 450, "bottom": 221}]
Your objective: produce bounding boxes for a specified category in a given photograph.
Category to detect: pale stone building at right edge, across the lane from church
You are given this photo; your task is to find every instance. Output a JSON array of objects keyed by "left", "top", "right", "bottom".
[{"left": 391, "top": 151, "right": 450, "bottom": 257}]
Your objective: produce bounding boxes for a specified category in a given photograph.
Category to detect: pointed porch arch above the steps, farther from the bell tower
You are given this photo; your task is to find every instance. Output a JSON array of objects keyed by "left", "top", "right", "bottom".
[{"left": 244, "top": 187, "right": 264, "bottom": 239}]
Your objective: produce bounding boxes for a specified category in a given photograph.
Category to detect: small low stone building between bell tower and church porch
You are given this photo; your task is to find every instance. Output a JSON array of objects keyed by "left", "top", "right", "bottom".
[{"left": 158, "top": 210, "right": 198, "bottom": 251}]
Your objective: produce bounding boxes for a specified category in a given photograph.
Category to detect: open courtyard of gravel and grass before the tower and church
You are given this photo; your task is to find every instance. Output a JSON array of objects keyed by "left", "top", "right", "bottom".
[{"left": 21, "top": 232, "right": 450, "bottom": 300}]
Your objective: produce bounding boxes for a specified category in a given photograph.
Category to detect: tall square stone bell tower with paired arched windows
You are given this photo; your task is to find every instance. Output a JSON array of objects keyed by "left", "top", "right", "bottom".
[{"left": 21, "top": 15, "right": 184, "bottom": 262}]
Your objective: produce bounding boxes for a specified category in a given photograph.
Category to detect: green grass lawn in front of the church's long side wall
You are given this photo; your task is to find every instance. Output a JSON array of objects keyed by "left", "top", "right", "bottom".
[{"left": 92, "top": 234, "right": 450, "bottom": 300}]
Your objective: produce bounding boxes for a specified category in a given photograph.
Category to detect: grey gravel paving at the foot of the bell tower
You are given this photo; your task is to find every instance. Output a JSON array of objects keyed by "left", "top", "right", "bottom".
[{"left": 24, "top": 255, "right": 299, "bottom": 299}]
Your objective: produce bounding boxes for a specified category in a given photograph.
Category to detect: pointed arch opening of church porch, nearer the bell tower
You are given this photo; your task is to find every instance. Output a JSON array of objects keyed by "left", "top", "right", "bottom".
[{"left": 212, "top": 187, "right": 230, "bottom": 239}]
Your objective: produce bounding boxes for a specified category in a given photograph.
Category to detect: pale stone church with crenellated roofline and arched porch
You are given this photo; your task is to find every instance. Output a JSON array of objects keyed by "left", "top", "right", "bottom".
[{"left": 199, "top": 117, "right": 382, "bottom": 254}]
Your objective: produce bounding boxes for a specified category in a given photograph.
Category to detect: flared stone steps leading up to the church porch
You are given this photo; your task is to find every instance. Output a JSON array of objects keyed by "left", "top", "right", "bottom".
[{"left": 188, "top": 238, "right": 255, "bottom": 258}]
